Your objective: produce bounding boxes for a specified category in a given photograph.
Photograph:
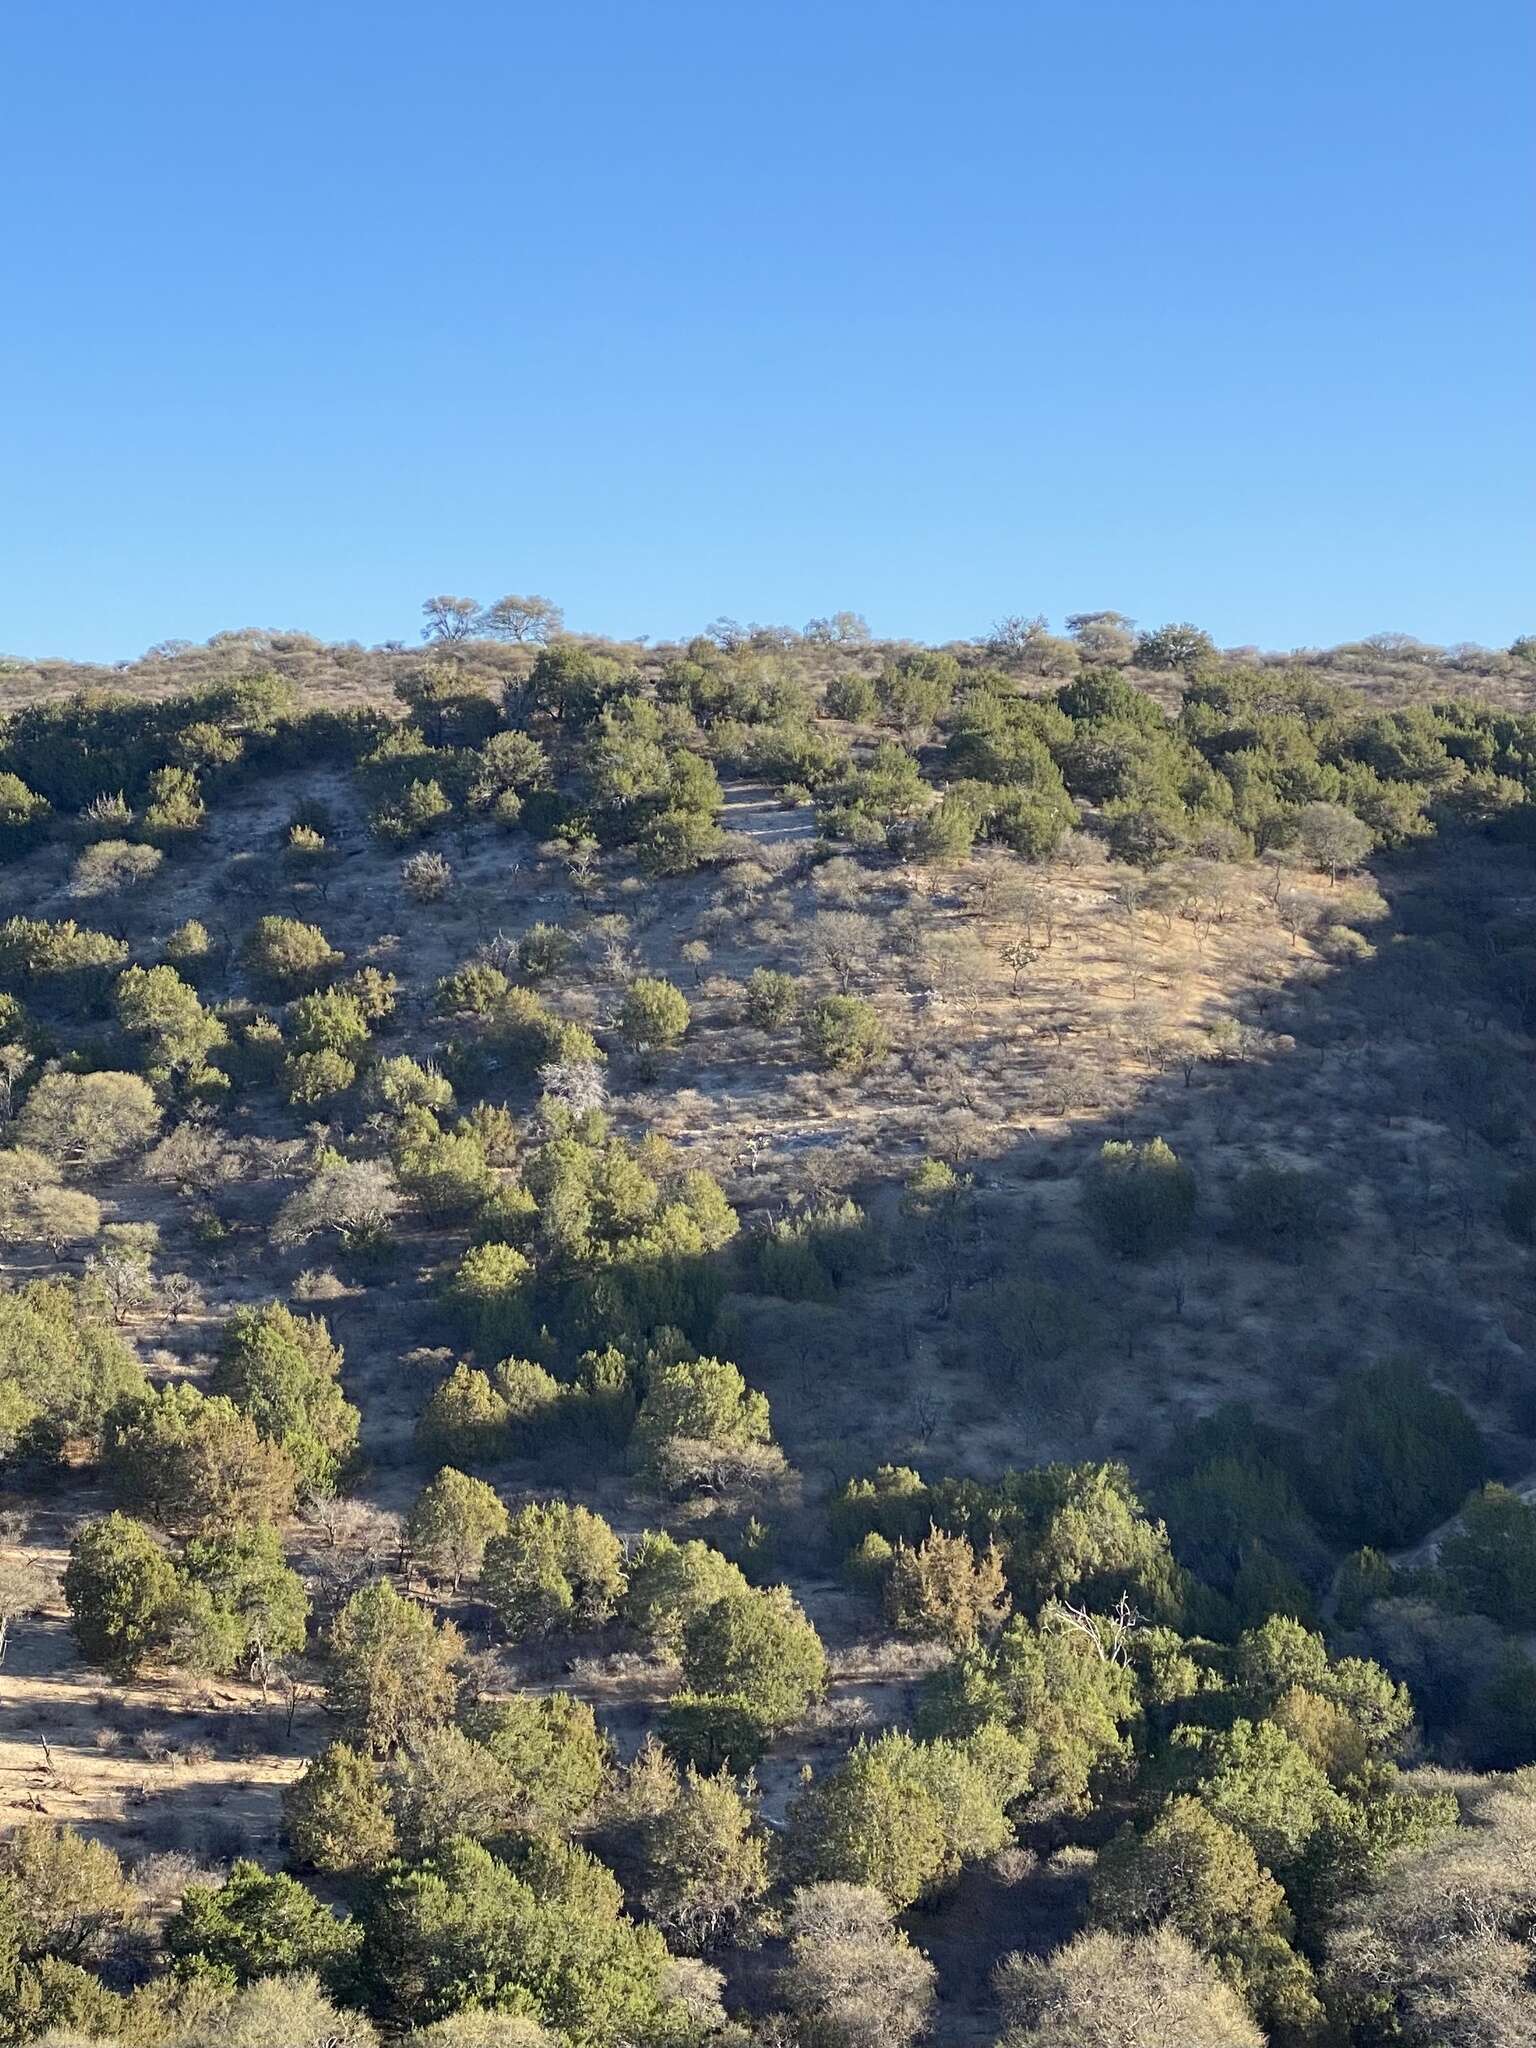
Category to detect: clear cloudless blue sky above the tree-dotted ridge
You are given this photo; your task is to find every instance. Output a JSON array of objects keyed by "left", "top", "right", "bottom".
[{"left": 0, "top": 0, "right": 1536, "bottom": 657}]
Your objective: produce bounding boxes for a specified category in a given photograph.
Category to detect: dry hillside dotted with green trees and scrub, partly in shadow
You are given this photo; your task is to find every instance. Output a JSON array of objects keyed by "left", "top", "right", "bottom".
[{"left": 0, "top": 600, "right": 1536, "bottom": 2048}]
